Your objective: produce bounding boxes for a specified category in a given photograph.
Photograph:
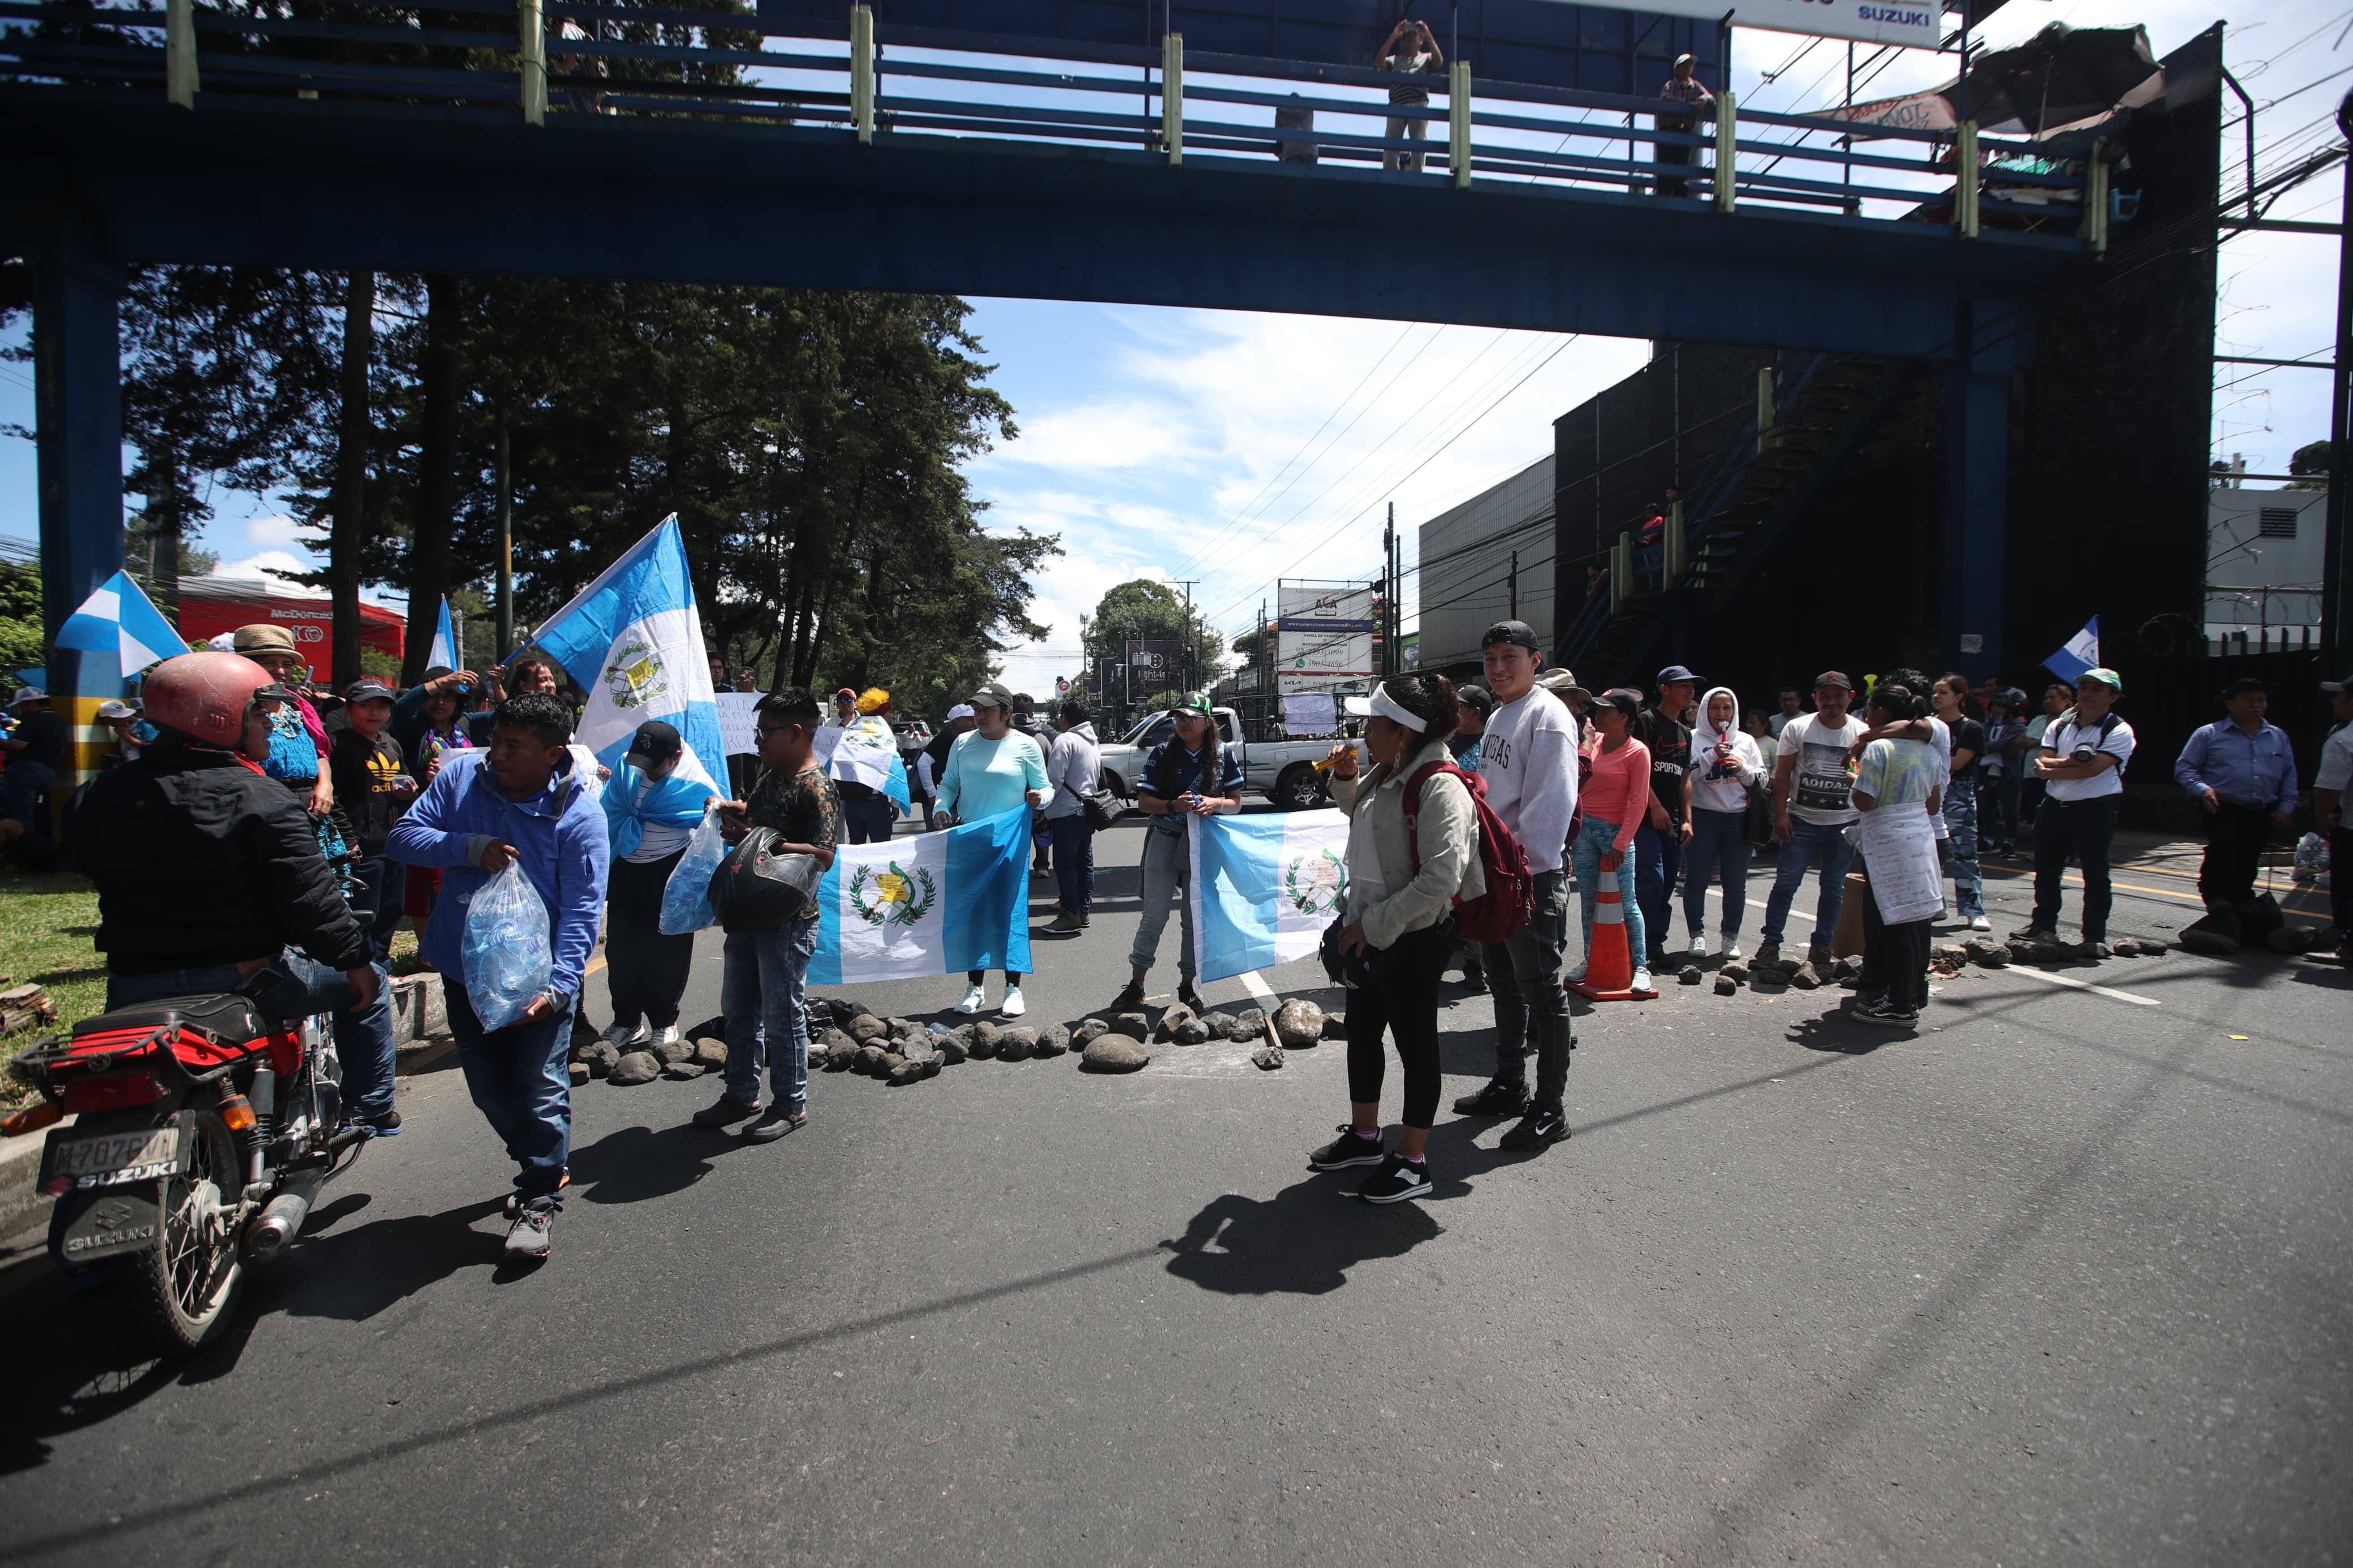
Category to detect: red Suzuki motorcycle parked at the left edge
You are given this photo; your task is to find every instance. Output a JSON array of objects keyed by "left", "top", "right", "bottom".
[{"left": 14, "top": 969, "right": 367, "bottom": 1357}]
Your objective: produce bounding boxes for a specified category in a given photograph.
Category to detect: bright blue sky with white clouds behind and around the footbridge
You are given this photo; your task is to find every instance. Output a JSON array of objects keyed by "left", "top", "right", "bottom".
[{"left": 0, "top": 0, "right": 2353, "bottom": 689}]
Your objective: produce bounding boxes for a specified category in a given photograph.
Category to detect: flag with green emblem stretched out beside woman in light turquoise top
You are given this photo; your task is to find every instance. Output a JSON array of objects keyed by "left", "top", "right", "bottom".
[{"left": 809, "top": 806, "right": 1031, "bottom": 985}]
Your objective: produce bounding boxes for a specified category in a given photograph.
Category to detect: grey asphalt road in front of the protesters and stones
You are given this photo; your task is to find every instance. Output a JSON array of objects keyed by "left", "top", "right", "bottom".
[{"left": 0, "top": 825, "right": 2353, "bottom": 1566}]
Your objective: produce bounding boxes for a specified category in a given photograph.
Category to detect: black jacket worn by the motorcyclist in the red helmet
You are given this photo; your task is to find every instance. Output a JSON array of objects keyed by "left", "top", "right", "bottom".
[{"left": 66, "top": 745, "right": 369, "bottom": 973}]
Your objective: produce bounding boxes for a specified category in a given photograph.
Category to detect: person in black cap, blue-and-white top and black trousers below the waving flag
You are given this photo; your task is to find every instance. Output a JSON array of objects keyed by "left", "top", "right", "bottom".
[{"left": 605, "top": 719, "right": 718, "bottom": 1051}]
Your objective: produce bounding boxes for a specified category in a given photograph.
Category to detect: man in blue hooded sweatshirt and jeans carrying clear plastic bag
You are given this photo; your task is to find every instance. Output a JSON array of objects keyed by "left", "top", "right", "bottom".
[{"left": 386, "top": 691, "right": 612, "bottom": 1260}]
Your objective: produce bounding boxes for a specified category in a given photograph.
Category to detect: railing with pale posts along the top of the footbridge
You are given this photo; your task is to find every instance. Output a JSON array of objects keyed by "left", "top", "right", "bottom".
[{"left": 0, "top": 0, "right": 2106, "bottom": 244}]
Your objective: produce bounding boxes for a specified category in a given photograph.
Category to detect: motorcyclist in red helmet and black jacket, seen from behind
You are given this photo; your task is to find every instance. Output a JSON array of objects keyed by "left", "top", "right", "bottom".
[{"left": 66, "top": 654, "right": 400, "bottom": 1135}]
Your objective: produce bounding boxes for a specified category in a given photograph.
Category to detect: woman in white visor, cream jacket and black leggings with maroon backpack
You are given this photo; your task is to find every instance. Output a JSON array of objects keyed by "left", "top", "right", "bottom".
[{"left": 1308, "top": 675, "right": 1468, "bottom": 1204}]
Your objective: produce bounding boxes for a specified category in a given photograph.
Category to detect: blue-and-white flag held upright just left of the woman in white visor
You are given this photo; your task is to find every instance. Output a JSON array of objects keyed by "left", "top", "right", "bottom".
[{"left": 1188, "top": 811, "right": 1348, "bottom": 980}]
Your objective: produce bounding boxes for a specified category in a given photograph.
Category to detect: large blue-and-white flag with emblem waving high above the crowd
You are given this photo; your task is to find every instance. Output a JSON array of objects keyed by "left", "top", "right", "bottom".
[{"left": 534, "top": 512, "right": 727, "bottom": 790}]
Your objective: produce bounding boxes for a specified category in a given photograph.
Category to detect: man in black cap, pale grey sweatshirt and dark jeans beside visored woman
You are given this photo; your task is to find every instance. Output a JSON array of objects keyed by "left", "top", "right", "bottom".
[{"left": 1454, "top": 621, "right": 1576, "bottom": 1154}]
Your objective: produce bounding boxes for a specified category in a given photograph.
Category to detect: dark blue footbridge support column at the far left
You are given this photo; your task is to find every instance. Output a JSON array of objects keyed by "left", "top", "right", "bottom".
[{"left": 28, "top": 211, "right": 122, "bottom": 788}]
